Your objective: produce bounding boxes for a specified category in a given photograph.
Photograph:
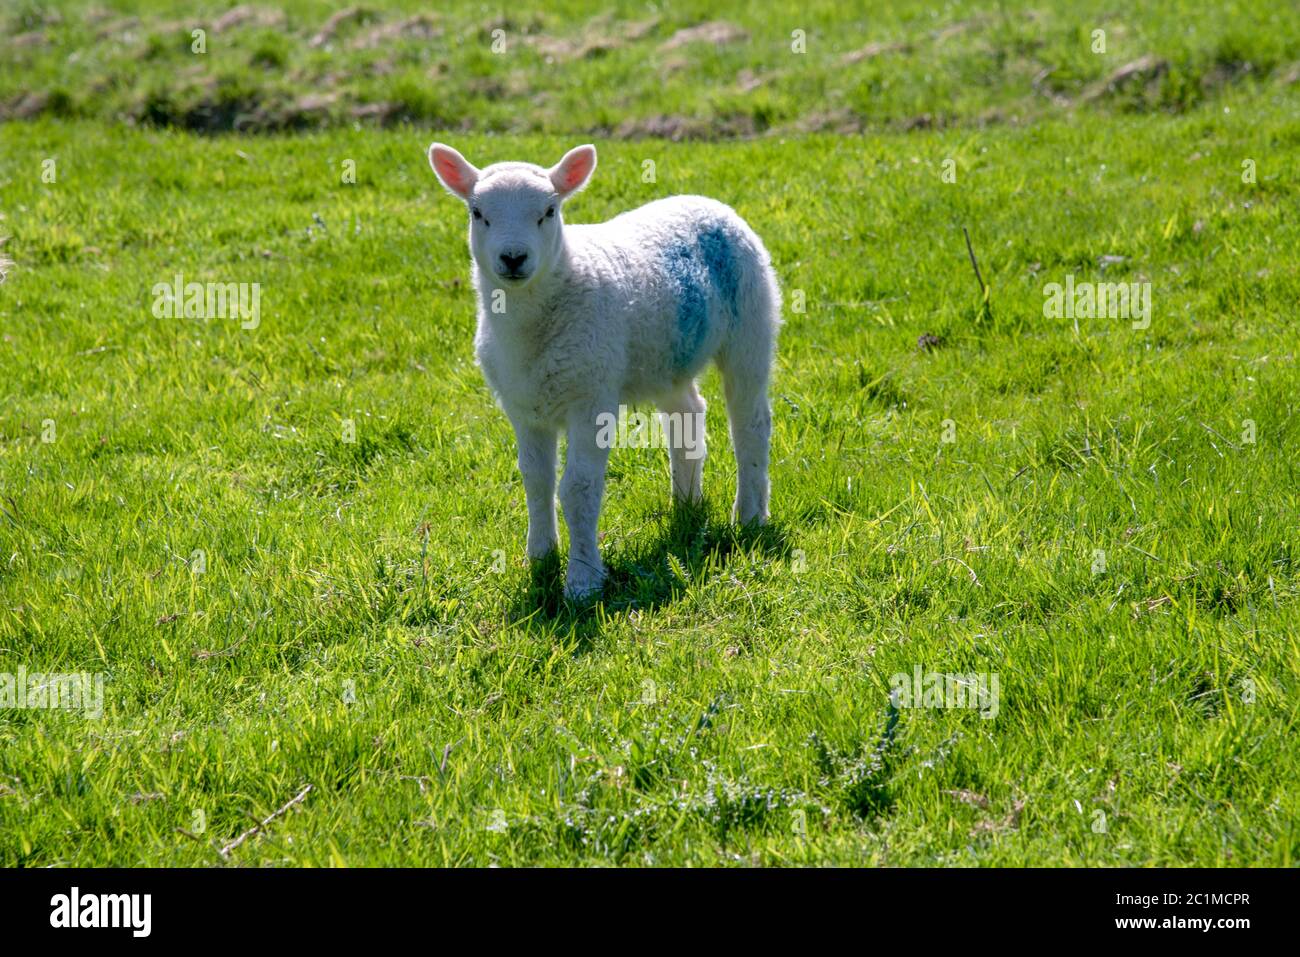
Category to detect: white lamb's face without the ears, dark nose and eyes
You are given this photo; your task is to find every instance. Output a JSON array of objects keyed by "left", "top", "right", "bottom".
[{"left": 468, "top": 163, "right": 562, "bottom": 286}]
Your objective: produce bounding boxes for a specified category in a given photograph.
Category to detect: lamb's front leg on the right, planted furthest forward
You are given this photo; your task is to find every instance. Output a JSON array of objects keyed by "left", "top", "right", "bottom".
[{"left": 560, "top": 411, "right": 612, "bottom": 598}]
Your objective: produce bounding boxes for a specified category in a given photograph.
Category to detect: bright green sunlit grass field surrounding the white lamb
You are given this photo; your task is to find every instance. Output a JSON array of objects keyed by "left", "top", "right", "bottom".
[{"left": 0, "top": 1, "right": 1300, "bottom": 866}]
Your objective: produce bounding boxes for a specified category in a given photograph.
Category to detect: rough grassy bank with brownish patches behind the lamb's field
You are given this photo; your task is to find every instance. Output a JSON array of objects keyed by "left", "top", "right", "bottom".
[{"left": 0, "top": 0, "right": 1300, "bottom": 132}]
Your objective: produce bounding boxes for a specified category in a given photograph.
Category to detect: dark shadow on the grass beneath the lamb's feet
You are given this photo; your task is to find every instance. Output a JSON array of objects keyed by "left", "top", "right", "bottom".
[{"left": 507, "top": 505, "right": 790, "bottom": 646}]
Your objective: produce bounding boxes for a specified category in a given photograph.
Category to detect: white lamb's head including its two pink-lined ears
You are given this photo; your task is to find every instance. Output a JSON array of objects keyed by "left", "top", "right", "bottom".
[{"left": 429, "top": 143, "right": 595, "bottom": 286}]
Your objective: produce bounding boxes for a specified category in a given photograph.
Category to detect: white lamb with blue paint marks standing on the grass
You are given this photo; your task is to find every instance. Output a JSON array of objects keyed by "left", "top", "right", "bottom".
[{"left": 429, "top": 143, "right": 781, "bottom": 599}]
